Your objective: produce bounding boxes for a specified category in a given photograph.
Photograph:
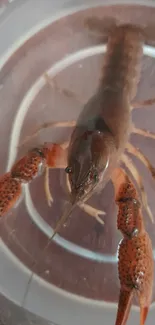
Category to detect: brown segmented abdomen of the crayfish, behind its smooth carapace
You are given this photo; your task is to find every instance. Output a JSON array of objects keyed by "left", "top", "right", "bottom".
[{"left": 102, "top": 25, "right": 144, "bottom": 101}]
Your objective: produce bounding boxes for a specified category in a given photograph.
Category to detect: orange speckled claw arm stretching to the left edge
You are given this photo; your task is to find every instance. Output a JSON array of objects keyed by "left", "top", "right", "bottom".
[{"left": 0, "top": 144, "right": 65, "bottom": 217}]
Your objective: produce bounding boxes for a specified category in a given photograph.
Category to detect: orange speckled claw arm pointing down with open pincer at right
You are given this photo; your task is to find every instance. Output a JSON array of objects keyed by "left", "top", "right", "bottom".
[{"left": 113, "top": 169, "right": 153, "bottom": 325}]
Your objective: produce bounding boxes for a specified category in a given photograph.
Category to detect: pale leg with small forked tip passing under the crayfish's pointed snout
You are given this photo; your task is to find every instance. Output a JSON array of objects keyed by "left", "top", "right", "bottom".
[{"left": 66, "top": 176, "right": 105, "bottom": 225}]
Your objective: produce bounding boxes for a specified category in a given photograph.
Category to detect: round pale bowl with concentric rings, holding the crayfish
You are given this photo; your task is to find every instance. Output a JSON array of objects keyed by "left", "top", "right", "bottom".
[{"left": 0, "top": 0, "right": 155, "bottom": 325}]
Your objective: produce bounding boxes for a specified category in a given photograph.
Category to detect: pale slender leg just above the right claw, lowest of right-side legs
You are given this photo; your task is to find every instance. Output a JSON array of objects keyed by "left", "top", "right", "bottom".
[{"left": 121, "top": 154, "right": 154, "bottom": 222}]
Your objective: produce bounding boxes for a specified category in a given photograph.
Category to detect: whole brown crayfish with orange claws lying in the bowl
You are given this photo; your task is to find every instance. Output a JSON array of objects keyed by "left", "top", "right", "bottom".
[{"left": 0, "top": 25, "right": 155, "bottom": 325}]
